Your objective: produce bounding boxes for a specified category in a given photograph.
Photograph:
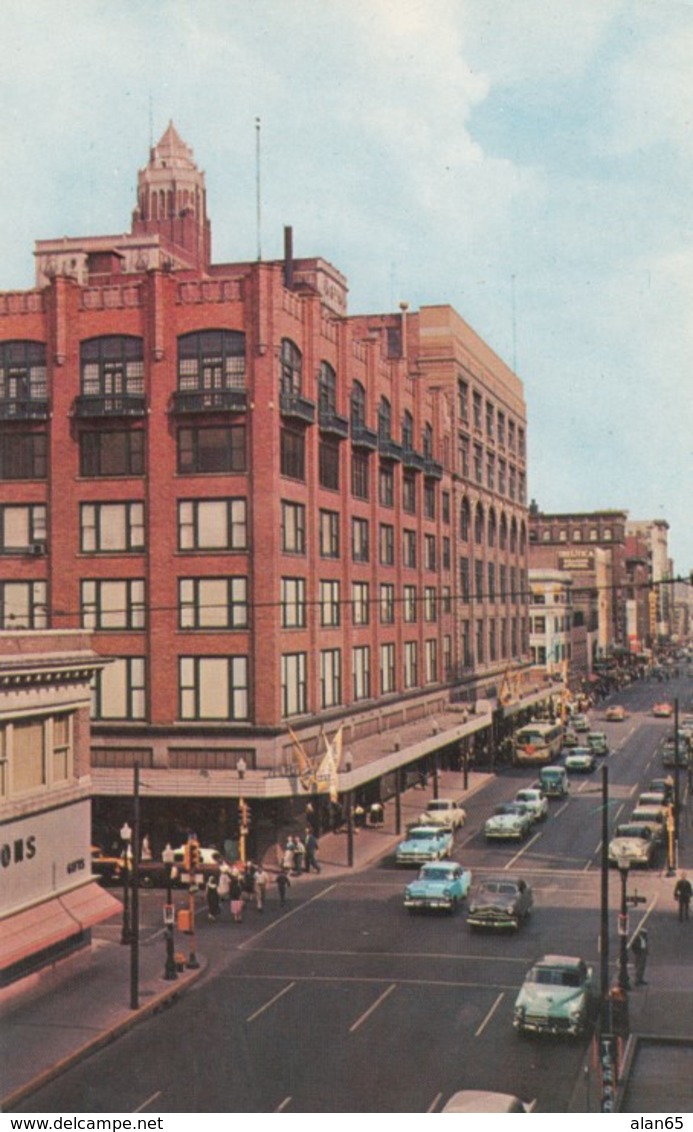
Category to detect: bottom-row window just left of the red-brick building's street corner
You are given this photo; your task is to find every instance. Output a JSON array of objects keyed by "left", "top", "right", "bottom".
[{"left": 179, "top": 657, "right": 249, "bottom": 720}]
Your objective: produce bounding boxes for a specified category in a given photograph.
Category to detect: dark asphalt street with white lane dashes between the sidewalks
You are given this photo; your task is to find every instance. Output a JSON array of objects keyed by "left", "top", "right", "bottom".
[{"left": 6, "top": 680, "right": 688, "bottom": 1113}]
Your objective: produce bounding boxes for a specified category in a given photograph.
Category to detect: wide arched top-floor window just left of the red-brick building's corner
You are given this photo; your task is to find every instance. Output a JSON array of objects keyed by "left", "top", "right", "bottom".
[{"left": 178, "top": 331, "right": 246, "bottom": 393}]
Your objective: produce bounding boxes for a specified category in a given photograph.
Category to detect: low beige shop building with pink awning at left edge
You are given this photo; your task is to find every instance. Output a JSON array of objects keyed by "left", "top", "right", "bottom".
[{"left": 0, "top": 632, "right": 120, "bottom": 987}]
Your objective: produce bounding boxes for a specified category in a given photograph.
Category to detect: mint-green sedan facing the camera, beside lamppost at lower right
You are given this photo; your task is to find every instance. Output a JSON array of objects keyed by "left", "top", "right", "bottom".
[{"left": 513, "top": 955, "right": 594, "bottom": 1037}]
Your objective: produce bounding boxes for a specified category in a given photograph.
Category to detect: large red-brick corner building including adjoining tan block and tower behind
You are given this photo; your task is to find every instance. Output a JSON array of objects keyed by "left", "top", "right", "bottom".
[{"left": 0, "top": 125, "right": 528, "bottom": 851}]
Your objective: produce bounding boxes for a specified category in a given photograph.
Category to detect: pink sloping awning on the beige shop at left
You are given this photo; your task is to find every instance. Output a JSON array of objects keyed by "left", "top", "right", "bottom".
[{"left": 0, "top": 881, "right": 121, "bottom": 970}]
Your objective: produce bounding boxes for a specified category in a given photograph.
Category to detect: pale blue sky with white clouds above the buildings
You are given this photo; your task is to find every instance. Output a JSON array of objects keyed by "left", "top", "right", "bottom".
[{"left": 0, "top": 0, "right": 693, "bottom": 566}]
